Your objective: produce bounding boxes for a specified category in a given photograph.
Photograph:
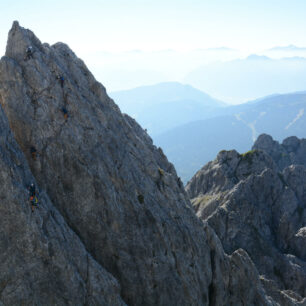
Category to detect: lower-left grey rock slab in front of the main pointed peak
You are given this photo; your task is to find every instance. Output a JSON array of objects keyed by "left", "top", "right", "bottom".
[{"left": 0, "top": 84, "right": 124, "bottom": 305}]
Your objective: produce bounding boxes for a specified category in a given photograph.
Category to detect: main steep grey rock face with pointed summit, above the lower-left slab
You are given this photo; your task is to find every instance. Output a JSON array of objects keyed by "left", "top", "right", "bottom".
[{"left": 0, "top": 23, "right": 209, "bottom": 305}]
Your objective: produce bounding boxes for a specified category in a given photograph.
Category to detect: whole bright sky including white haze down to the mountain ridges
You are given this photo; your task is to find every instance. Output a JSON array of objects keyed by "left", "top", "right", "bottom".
[{"left": 0, "top": 0, "right": 306, "bottom": 103}]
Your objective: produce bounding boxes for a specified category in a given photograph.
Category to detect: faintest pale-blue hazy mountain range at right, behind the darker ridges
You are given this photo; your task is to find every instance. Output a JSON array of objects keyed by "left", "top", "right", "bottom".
[{"left": 184, "top": 55, "right": 306, "bottom": 103}]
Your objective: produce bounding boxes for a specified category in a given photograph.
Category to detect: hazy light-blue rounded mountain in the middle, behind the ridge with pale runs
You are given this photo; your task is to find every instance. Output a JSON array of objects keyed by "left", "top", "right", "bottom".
[{"left": 110, "top": 82, "right": 226, "bottom": 136}]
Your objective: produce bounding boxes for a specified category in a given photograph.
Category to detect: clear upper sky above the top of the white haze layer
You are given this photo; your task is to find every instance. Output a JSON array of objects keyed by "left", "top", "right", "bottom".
[{"left": 0, "top": 0, "right": 306, "bottom": 53}]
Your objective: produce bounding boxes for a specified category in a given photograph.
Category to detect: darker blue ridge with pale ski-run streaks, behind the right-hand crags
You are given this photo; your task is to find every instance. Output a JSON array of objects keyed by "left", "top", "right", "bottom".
[{"left": 153, "top": 92, "right": 306, "bottom": 182}]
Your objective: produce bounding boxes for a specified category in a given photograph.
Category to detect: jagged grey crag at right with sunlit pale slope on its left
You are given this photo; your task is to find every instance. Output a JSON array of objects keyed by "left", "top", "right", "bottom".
[{"left": 186, "top": 137, "right": 306, "bottom": 305}]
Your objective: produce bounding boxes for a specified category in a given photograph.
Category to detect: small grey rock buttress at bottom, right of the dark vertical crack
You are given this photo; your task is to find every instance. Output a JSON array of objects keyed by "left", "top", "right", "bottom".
[{"left": 204, "top": 222, "right": 278, "bottom": 306}]
